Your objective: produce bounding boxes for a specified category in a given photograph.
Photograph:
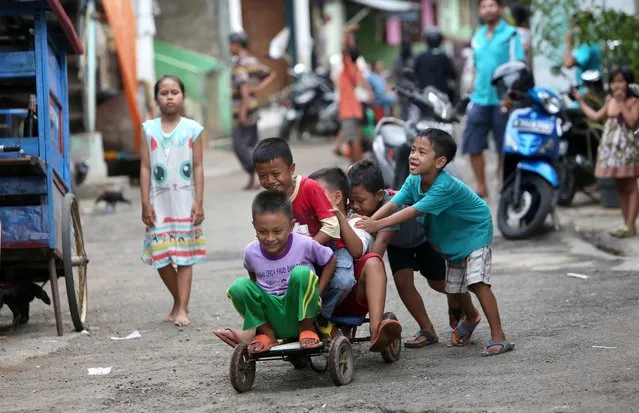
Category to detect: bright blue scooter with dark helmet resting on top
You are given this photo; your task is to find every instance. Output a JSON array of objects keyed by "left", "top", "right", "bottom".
[{"left": 492, "top": 61, "right": 569, "bottom": 239}]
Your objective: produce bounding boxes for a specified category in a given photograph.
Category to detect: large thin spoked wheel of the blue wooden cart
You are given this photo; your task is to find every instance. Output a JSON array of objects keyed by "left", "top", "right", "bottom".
[{"left": 62, "top": 193, "right": 89, "bottom": 331}]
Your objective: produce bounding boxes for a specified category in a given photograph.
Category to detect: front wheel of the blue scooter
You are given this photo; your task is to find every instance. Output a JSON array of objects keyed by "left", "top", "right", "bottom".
[{"left": 497, "top": 173, "right": 553, "bottom": 240}]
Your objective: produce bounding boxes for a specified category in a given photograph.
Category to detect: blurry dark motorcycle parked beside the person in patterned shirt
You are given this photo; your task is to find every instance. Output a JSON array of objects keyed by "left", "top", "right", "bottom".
[{"left": 279, "top": 64, "right": 340, "bottom": 140}]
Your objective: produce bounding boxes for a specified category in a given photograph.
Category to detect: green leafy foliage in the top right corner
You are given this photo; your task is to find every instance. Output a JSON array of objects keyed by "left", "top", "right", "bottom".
[{"left": 532, "top": 0, "right": 639, "bottom": 75}]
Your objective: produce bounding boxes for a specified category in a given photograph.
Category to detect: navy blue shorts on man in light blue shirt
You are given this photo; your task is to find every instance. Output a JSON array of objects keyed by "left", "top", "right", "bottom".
[{"left": 462, "top": 103, "right": 508, "bottom": 154}]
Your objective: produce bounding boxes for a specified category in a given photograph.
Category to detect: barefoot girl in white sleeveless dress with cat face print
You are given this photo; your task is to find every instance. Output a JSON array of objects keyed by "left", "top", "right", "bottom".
[{"left": 140, "top": 75, "right": 206, "bottom": 326}]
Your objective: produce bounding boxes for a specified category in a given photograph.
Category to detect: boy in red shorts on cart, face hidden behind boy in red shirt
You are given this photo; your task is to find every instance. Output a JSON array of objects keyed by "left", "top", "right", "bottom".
[{"left": 309, "top": 167, "right": 402, "bottom": 352}]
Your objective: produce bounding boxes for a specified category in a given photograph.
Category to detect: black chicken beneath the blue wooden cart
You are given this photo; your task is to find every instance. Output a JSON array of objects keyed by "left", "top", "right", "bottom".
[{"left": 0, "top": 280, "right": 51, "bottom": 331}]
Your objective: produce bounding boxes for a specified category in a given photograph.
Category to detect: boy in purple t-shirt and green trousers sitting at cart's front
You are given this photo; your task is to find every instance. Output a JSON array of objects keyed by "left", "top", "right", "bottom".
[{"left": 227, "top": 190, "right": 337, "bottom": 354}]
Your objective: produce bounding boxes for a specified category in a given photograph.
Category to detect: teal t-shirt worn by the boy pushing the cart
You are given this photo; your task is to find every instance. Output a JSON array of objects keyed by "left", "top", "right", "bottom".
[{"left": 391, "top": 171, "right": 493, "bottom": 262}]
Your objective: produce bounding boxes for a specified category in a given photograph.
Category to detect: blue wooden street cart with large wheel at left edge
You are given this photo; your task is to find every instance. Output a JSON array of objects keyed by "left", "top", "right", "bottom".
[{"left": 0, "top": 0, "right": 88, "bottom": 335}]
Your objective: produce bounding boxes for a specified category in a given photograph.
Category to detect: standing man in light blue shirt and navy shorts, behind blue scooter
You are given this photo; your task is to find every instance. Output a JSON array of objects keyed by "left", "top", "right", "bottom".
[{"left": 462, "top": 0, "right": 526, "bottom": 198}]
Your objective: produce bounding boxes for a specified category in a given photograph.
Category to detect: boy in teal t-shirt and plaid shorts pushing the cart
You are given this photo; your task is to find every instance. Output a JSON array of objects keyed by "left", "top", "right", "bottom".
[{"left": 357, "top": 129, "right": 515, "bottom": 356}]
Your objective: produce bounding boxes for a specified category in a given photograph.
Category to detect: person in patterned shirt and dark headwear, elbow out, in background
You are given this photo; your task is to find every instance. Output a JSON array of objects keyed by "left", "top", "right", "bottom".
[{"left": 229, "top": 32, "right": 275, "bottom": 189}]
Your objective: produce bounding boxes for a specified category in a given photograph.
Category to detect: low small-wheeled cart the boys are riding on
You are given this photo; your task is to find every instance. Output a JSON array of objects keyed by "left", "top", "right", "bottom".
[{"left": 229, "top": 312, "right": 402, "bottom": 393}]
